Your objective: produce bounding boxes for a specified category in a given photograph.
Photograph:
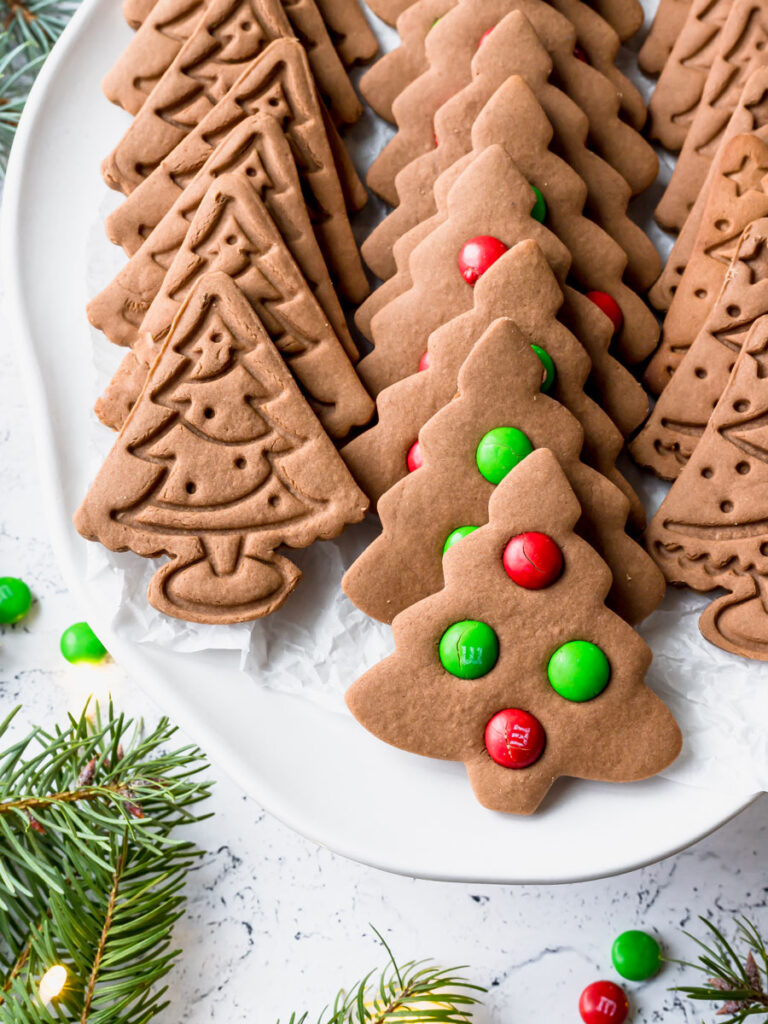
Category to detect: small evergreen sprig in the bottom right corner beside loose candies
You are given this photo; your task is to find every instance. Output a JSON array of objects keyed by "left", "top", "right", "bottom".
[{"left": 674, "top": 918, "right": 768, "bottom": 1024}]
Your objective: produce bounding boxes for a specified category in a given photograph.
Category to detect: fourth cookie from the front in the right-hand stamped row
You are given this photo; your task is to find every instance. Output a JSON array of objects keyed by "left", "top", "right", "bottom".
[{"left": 648, "top": 68, "right": 768, "bottom": 309}]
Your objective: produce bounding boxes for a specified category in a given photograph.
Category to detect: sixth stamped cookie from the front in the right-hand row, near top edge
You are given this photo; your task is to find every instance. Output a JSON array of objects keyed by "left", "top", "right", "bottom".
[{"left": 648, "top": 0, "right": 734, "bottom": 152}]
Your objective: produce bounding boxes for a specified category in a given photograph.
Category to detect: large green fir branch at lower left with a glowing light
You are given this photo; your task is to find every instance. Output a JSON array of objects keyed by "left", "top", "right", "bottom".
[{"left": 0, "top": 706, "right": 210, "bottom": 1024}]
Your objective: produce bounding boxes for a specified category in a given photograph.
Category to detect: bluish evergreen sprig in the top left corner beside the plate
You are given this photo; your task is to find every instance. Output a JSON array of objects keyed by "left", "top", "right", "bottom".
[{"left": 0, "top": 0, "right": 79, "bottom": 177}]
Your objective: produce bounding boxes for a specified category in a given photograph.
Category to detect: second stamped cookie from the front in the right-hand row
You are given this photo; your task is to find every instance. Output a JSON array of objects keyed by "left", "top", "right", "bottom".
[{"left": 630, "top": 219, "right": 768, "bottom": 480}]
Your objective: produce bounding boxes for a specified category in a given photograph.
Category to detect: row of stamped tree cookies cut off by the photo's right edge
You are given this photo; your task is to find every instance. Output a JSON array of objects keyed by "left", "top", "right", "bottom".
[{"left": 631, "top": 0, "right": 768, "bottom": 659}]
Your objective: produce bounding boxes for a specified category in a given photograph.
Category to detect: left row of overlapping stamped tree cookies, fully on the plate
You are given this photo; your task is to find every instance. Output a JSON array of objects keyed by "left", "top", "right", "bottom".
[{"left": 76, "top": 0, "right": 376, "bottom": 624}]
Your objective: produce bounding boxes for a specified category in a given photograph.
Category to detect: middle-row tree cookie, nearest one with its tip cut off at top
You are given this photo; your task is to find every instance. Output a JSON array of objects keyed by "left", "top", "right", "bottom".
[{"left": 368, "top": 0, "right": 658, "bottom": 205}]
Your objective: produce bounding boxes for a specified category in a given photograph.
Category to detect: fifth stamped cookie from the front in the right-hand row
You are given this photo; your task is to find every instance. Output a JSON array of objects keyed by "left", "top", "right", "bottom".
[{"left": 654, "top": 0, "right": 768, "bottom": 231}]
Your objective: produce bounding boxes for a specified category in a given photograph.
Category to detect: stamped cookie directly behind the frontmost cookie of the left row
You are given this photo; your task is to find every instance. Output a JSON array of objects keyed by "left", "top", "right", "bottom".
[{"left": 97, "top": 167, "right": 373, "bottom": 437}]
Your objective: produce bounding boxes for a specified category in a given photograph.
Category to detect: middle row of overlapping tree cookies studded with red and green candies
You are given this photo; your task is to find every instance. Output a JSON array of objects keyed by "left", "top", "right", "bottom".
[{"left": 341, "top": 0, "right": 680, "bottom": 813}]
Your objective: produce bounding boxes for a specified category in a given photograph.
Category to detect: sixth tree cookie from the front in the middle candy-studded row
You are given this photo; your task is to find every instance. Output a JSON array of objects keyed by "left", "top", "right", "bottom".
[{"left": 361, "top": 10, "right": 660, "bottom": 289}]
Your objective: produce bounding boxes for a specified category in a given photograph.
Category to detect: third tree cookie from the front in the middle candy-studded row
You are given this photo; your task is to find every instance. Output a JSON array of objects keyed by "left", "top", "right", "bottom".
[{"left": 341, "top": 241, "right": 645, "bottom": 520}]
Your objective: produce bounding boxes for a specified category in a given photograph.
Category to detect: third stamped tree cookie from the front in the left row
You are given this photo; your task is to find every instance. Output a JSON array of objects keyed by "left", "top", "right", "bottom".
[{"left": 88, "top": 114, "right": 358, "bottom": 360}]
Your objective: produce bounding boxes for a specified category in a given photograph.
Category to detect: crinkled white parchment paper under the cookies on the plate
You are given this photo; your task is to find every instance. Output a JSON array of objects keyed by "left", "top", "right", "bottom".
[{"left": 83, "top": 0, "right": 768, "bottom": 792}]
